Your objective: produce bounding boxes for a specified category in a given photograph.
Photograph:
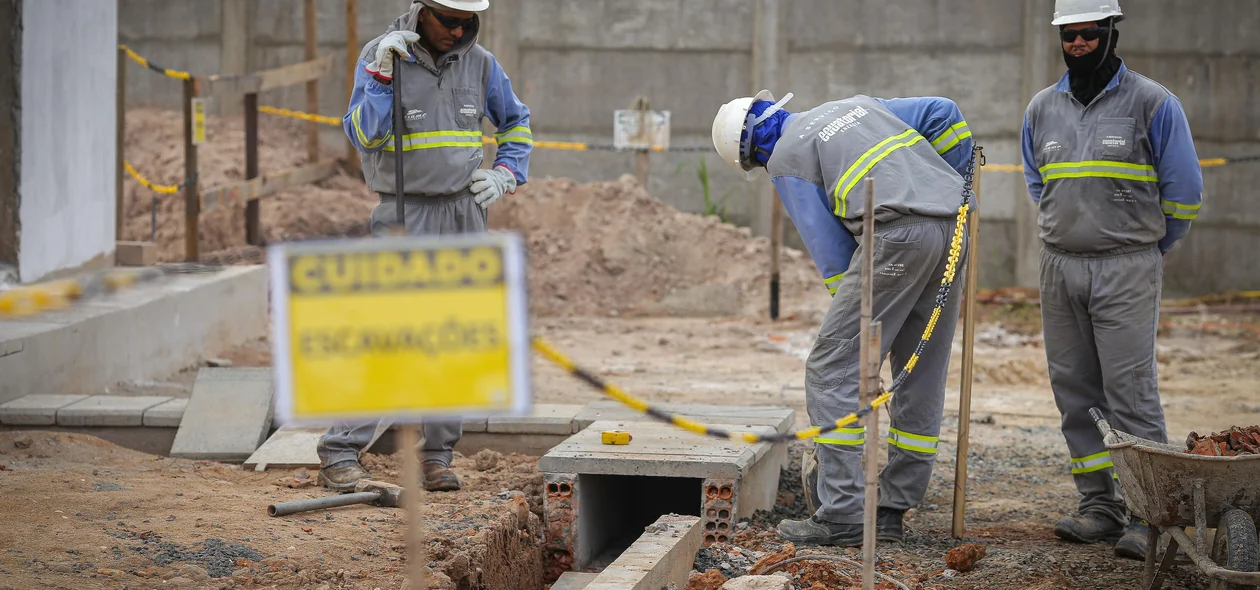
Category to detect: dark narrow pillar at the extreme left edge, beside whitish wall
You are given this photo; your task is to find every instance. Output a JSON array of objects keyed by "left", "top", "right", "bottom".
[{"left": 0, "top": 0, "right": 21, "bottom": 271}]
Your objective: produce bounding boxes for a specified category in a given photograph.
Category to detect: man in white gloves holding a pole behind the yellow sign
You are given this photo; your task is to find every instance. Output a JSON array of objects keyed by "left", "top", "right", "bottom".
[{"left": 318, "top": 0, "right": 533, "bottom": 490}]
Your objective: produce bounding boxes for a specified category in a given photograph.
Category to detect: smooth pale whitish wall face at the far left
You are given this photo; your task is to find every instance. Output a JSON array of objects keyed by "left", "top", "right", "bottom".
[{"left": 18, "top": 0, "right": 117, "bottom": 282}]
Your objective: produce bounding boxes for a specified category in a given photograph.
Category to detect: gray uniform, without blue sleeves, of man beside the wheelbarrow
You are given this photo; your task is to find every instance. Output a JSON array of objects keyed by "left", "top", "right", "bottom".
[{"left": 1027, "top": 66, "right": 1172, "bottom": 522}]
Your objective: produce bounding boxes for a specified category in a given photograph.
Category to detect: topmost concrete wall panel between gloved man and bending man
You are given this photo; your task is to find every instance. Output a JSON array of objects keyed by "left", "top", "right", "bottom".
[{"left": 519, "top": 0, "right": 755, "bottom": 52}]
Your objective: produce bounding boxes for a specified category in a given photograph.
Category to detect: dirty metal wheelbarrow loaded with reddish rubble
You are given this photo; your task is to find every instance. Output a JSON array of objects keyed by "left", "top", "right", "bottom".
[{"left": 1090, "top": 408, "right": 1260, "bottom": 590}]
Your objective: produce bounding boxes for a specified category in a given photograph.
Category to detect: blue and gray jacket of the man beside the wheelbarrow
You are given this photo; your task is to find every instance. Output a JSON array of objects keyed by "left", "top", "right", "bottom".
[{"left": 1021, "top": 63, "right": 1203, "bottom": 252}]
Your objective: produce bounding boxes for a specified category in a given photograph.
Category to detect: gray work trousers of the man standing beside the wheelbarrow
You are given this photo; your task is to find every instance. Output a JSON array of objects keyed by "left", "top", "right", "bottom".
[{"left": 1041, "top": 245, "right": 1167, "bottom": 522}]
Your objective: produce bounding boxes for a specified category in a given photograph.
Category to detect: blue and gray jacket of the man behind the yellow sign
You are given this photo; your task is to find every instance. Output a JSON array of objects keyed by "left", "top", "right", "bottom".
[{"left": 341, "top": 3, "right": 533, "bottom": 199}]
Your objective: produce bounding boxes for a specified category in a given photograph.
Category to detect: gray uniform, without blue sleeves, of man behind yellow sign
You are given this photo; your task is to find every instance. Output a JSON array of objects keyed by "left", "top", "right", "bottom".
[{"left": 318, "top": 3, "right": 493, "bottom": 466}]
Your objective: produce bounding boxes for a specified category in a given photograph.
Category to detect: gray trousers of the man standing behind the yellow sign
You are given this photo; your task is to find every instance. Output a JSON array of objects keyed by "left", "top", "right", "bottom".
[{"left": 316, "top": 194, "right": 489, "bottom": 466}]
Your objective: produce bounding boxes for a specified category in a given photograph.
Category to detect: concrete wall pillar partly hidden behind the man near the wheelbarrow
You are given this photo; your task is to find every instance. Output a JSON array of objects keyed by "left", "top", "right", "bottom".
[{"left": 1014, "top": 0, "right": 1055, "bottom": 287}]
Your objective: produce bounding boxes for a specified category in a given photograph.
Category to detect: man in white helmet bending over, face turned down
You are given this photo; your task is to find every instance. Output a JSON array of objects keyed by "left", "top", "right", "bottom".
[{"left": 713, "top": 91, "right": 971, "bottom": 546}]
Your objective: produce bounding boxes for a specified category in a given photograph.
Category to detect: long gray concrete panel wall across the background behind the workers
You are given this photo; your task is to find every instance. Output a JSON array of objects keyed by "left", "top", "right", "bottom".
[{"left": 118, "top": 0, "right": 1260, "bottom": 295}]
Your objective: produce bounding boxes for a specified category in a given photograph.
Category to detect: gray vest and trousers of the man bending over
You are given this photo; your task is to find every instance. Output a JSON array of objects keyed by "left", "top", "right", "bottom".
[{"left": 766, "top": 96, "right": 974, "bottom": 524}]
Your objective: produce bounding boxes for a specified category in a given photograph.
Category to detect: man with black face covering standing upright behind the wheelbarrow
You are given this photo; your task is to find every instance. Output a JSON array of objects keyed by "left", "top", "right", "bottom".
[{"left": 1022, "top": 0, "right": 1203, "bottom": 560}]
